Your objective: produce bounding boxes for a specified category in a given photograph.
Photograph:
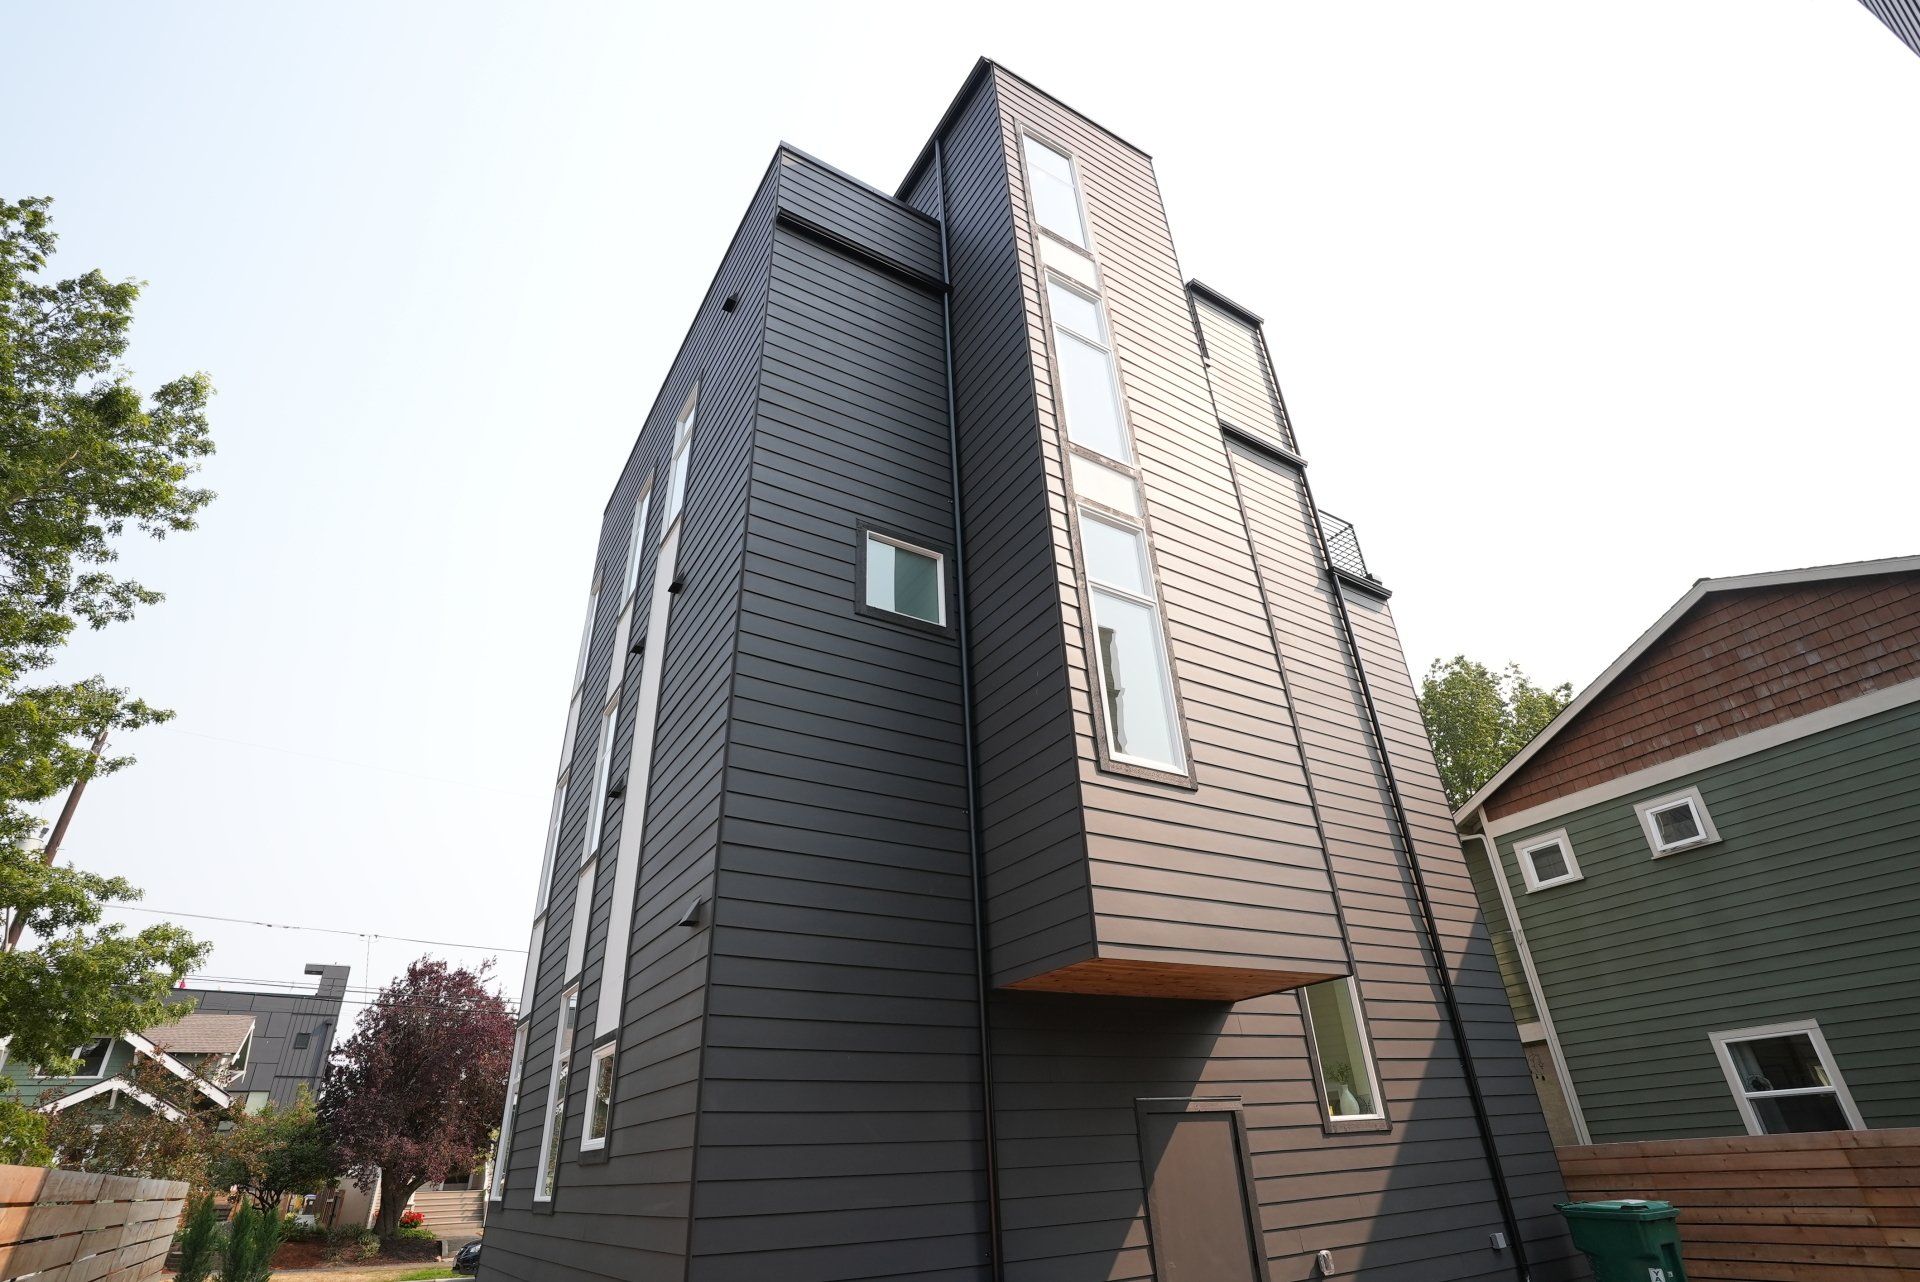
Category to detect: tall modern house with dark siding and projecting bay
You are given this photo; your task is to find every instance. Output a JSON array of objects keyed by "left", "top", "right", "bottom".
[{"left": 482, "top": 61, "right": 1576, "bottom": 1282}]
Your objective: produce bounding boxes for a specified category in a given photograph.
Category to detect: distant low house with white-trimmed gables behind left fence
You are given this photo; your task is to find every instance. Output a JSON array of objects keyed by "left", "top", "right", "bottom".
[{"left": 0, "top": 1011, "right": 253, "bottom": 1121}]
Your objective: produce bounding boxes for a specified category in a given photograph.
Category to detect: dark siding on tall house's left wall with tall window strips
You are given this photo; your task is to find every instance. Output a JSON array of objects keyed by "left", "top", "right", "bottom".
[{"left": 486, "top": 152, "right": 774, "bottom": 1282}]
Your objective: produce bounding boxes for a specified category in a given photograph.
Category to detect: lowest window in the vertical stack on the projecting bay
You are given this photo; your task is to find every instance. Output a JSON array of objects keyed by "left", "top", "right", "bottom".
[{"left": 1079, "top": 509, "right": 1187, "bottom": 772}]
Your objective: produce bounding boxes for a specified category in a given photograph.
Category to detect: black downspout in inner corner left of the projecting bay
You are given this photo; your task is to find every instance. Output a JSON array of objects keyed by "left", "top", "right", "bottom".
[{"left": 933, "top": 136, "right": 1006, "bottom": 1282}]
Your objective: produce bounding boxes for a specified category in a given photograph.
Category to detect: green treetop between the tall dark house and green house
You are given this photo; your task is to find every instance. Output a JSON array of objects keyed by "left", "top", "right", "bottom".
[{"left": 1421, "top": 654, "right": 1572, "bottom": 810}]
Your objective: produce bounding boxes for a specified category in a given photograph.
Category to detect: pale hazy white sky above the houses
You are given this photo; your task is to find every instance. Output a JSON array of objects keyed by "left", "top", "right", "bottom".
[{"left": 0, "top": 0, "right": 1920, "bottom": 1013}]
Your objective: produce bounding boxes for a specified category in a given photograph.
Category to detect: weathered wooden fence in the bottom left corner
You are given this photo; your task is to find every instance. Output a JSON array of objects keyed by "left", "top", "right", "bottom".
[{"left": 0, "top": 1167, "right": 186, "bottom": 1282}]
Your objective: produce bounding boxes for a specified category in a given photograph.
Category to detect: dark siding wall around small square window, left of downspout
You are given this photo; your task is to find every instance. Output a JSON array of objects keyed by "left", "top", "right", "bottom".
[{"left": 691, "top": 202, "right": 987, "bottom": 1282}]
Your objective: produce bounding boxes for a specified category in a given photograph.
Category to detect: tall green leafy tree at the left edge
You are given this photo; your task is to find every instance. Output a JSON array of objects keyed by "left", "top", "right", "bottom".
[{"left": 0, "top": 198, "right": 213, "bottom": 1067}]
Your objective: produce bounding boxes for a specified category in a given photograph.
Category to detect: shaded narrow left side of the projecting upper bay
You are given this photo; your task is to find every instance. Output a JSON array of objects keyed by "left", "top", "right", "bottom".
[{"left": 910, "top": 77, "right": 1092, "bottom": 983}]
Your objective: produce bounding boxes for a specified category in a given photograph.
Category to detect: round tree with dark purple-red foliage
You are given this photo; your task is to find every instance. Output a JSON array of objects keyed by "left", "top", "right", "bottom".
[{"left": 321, "top": 958, "right": 513, "bottom": 1238}]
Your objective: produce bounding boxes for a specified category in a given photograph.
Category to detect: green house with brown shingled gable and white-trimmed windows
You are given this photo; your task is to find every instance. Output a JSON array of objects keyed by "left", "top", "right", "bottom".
[{"left": 1453, "top": 557, "right": 1920, "bottom": 1144}]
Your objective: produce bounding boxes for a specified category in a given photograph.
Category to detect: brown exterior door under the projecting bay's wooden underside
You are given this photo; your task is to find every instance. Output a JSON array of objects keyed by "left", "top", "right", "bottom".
[{"left": 1137, "top": 1100, "right": 1267, "bottom": 1282}]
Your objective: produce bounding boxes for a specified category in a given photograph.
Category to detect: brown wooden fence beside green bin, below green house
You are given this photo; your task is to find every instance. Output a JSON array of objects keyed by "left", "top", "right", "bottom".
[{"left": 1559, "top": 1128, "right": 1920, "bottom": 1282}]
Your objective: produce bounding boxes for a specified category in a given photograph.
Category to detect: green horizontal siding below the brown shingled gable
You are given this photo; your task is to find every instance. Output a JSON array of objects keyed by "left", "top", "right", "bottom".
[{"left": 1476, "top": 704, "right": 1920, "bottom": 1142}]
